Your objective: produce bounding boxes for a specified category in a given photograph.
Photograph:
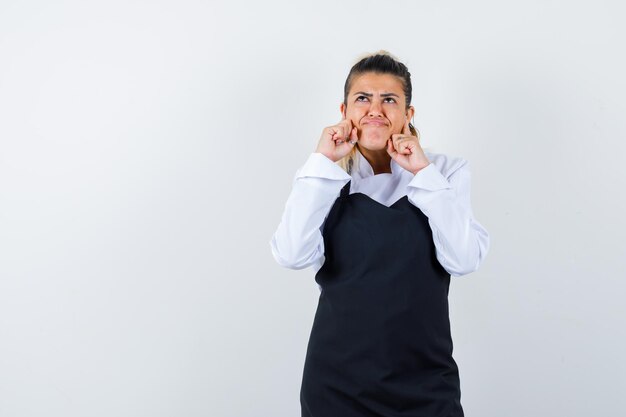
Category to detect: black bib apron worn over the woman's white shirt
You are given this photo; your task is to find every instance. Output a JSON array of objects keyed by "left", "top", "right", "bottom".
[{"left": 300, "top": 182, "right": 463, "bottom": 417}]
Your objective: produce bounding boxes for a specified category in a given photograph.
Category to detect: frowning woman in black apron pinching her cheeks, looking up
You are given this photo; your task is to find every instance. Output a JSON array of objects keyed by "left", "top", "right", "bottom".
[{"left": 270, "top": 51, "right": 489, "bottom": 417}]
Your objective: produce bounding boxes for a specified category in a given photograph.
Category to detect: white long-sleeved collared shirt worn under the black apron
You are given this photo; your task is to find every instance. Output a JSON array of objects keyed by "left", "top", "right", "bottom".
[{"left": 270, "top": 149, "right": 489, "bottom": 277}]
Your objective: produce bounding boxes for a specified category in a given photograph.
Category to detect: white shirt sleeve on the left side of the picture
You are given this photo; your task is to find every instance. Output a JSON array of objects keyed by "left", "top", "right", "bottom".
[{"left": 270, "top": 152, "right": 351, "bottom": 269}]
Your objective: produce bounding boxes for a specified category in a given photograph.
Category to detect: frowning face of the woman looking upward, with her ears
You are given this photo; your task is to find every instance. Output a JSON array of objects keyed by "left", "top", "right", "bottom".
[{"left": 340, "top": 72, "right": 415, "bottom": 150}]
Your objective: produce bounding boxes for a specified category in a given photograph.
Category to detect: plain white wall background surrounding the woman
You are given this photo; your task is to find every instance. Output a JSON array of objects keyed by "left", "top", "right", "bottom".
[{"left": 0, "top": 0, "right": 626, "bottom": 417}]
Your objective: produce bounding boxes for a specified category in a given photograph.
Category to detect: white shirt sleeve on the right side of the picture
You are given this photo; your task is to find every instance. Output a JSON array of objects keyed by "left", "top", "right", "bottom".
[{"left": 407, "top": 158, "right": 489, "bottom": 277}]
